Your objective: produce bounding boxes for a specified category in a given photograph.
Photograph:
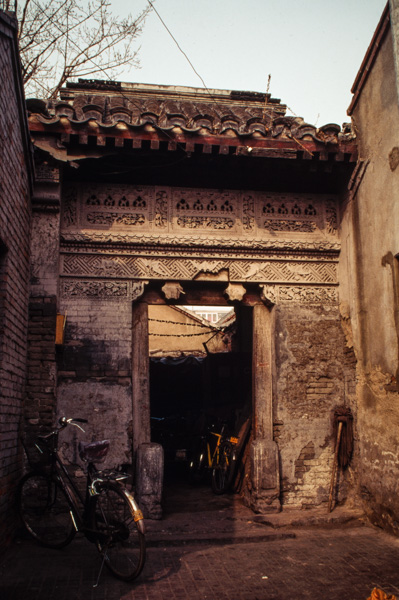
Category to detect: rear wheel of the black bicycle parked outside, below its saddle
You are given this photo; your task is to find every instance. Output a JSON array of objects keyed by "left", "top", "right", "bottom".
[{"left": 92, "top": 482, "right": 145, "bottom": 581}]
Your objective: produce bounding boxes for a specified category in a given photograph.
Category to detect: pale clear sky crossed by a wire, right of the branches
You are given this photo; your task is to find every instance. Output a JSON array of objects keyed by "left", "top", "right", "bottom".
[{"left": 111, "top": 0, "right": 386, "bottom": 126}]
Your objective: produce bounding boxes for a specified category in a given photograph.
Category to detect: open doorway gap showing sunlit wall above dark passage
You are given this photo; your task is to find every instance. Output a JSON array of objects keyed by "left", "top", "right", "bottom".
[{"left": 148, "top": 306, "right": 252, "bottom": 506}]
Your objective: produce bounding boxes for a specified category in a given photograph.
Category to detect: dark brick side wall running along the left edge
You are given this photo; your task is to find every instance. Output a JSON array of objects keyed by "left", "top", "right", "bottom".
[{"left": 0, "top": 11, "right": 32, "bottom": 547}]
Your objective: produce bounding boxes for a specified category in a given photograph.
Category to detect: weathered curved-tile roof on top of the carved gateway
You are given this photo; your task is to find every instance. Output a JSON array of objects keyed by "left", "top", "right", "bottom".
[{"left": 28, "top": 82, "right": 354, "bottom": 149}]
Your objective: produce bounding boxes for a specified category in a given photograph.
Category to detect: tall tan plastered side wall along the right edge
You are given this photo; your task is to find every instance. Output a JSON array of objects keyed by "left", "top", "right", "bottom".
[{"left": 340, "top": 21, "right": 399, "bottom": 534}]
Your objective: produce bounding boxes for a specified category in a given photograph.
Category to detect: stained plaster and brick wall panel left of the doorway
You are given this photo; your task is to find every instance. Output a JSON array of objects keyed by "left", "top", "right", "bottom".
[{"left": 57, "top": 298, "right": 132, "bottom": 467}]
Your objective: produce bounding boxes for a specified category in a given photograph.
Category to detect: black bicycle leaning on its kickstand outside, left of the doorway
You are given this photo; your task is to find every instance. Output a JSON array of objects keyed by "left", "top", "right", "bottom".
[{"left": 17, "top": 417, "right": 145, "bottom": 587}]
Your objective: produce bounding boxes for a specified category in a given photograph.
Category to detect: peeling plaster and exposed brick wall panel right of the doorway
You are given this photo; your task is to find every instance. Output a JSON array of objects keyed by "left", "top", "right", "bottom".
[{"left": 274, "top": 305, "right": 356, "bottom": 508}]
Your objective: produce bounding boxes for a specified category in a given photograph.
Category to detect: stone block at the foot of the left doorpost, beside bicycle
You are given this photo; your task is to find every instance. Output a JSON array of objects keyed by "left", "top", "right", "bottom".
[{"left": 136, "top": 442, "right": 164, "bottom": 519}]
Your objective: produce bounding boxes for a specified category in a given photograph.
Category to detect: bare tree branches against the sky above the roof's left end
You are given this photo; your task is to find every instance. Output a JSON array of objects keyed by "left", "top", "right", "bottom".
[{"left": 17, "top": 0, "right": 151, "bottom": 98}]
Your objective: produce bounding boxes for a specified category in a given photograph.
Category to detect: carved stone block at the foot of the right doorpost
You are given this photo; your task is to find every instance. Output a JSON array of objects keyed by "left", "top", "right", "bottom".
[{"left": 245, "top": 439, "right": 281, "bottom": 513}]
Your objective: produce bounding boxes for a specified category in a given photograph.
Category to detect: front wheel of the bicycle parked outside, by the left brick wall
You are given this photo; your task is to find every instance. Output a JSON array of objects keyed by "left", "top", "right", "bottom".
[{"left": 17, "top": 472, "right": 76, "bottom": 548}]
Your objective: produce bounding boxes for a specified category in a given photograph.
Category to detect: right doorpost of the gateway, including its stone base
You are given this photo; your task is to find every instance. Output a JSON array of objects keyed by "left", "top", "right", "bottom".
[{"left": 249, "top": 304, "right": 281, "bottom": 512}]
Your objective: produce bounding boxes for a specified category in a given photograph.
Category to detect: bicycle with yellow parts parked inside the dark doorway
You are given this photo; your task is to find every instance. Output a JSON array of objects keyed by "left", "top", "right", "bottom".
[{"left": 189, "top": 424, "right": 238, "bottom": 494}]
